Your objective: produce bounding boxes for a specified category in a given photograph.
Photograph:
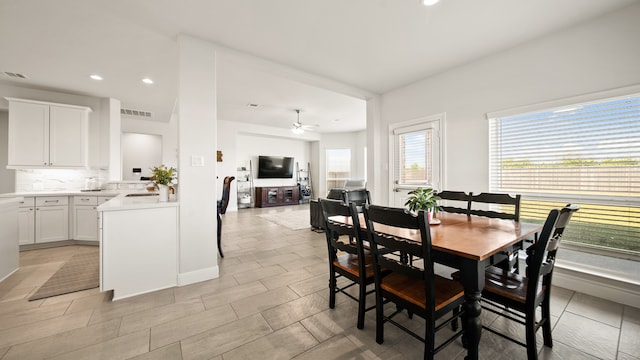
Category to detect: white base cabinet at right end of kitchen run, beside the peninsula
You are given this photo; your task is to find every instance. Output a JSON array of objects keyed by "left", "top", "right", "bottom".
[{"left": 71, "top": 195, "right": 113, "bottom": 242}]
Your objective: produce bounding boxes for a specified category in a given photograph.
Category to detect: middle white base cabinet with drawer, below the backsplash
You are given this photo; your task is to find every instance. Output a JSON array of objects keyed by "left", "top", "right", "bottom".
[{"left": 35, "top": 196, "right": 69, "bottom": 244}]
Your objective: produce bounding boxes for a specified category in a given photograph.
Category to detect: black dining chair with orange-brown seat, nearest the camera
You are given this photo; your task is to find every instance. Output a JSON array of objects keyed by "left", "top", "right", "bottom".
[{"left": 364, "top": 205, "right": 464, "bottom": 359}]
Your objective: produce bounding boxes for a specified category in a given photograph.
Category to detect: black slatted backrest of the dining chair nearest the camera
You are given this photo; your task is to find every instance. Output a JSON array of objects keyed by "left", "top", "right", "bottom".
[{"left": 364, "top": 205, "right": 435, "bottom": 310}]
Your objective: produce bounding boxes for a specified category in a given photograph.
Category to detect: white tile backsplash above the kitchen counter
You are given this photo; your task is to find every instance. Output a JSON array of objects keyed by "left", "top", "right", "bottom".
[{"left": 15, "top": 169, "right": 108, "bottom": 192}]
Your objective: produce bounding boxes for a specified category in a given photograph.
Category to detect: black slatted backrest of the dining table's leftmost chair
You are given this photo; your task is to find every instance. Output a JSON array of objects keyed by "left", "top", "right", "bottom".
[{"left": 319, "top": 199, "right": 364, "bottom": 260}]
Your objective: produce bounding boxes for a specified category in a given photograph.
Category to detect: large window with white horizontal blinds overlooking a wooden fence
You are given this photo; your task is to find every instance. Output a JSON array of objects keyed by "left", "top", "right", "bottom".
[{"left": 489, "top": 95, "right": 640, "bottom": 258}]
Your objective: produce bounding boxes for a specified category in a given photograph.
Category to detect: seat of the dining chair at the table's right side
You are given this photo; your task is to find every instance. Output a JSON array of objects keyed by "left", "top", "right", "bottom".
[{"left": 484, "top": 266, "right": 544, "bottom": 304}]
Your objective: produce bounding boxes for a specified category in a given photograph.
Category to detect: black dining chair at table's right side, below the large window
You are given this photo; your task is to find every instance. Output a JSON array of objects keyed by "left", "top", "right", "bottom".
[{"left": 482, "top": 204, "right": 579, "bottom": 360}]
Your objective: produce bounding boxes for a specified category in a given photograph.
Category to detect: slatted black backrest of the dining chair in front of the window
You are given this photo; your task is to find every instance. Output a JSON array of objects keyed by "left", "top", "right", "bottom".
[{"left": 526, "top": 204, "right": 579, "bottom": 302}]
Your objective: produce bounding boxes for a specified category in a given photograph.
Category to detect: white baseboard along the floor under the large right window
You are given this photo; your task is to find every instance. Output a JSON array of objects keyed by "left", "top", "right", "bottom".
[{"left": 553, "top": 264, "right": 640, "bottom": 307}]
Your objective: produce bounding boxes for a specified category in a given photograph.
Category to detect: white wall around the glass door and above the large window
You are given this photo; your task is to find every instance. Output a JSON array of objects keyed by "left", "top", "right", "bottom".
[{"left": 378, "top": 4, "right": 640, "bottom": 205}]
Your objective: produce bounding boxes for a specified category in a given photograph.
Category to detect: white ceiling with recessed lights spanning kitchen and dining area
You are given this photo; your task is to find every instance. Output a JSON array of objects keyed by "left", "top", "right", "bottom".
[{"left": 0, "top": 0, "right": 638, "bottom": 132}]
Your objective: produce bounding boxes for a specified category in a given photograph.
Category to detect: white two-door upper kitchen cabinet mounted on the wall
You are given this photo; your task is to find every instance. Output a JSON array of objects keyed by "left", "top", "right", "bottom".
[{"left": 6, "top": 98, "right": 91, "bottom": 168}]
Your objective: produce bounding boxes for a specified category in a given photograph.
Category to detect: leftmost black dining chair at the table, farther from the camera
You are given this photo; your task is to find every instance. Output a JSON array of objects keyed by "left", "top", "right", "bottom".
[{"left": 319, "top": 199, "right": 375, "bottom": 329}]
